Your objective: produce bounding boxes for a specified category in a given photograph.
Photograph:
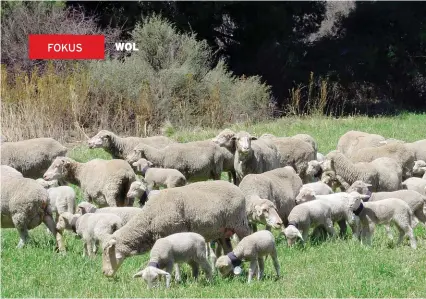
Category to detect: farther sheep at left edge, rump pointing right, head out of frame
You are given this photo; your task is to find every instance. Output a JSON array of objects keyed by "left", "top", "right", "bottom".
[{"left": 0, "top": 138, "right": 67, "bottom": 179}]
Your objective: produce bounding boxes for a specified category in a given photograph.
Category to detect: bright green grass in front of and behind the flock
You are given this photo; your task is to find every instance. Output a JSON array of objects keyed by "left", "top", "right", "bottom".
[{"left": 1, "top": 114, "right": 426, "bottom": 298}]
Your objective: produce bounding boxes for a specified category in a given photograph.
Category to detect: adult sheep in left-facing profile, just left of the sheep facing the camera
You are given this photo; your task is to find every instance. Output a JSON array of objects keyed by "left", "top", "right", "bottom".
[{"left": 126, "top": 141, "right": 225, "bottom": 181}]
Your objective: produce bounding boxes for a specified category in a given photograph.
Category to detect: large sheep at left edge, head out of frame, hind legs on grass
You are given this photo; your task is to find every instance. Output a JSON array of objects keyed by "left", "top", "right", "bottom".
[{"left": 0, "top": 171, "right": 65, "bottom": 251}]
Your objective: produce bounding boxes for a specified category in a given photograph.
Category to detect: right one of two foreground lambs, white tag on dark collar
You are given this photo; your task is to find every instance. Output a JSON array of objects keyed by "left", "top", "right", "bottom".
[{"left": 216, "top": 230, "right": 280, "bottom": 283}]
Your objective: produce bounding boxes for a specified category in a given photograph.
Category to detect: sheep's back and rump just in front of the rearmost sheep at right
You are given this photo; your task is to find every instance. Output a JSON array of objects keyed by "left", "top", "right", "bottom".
[{"left": 351, "top": 143, "right": 415, "bottom": 179}]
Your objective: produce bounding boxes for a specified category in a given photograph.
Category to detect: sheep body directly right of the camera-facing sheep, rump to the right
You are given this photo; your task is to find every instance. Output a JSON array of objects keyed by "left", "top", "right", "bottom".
[{"left": 259, "top": 134, "right": 316, "bottom": 183}]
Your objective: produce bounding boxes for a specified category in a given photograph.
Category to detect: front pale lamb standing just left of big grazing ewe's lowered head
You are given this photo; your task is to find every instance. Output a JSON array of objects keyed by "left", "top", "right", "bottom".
[{"left": 56, "top": 212, "right": 122, "bottom": 257}]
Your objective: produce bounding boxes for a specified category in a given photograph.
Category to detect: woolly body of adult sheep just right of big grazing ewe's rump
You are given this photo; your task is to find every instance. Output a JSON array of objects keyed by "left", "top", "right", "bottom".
[{"left": 240, "top": 166, "right": 302, "bottom": 230}]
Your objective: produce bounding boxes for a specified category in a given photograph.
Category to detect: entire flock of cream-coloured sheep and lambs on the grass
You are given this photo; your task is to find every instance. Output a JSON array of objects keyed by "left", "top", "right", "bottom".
[{"left": 1, "top": 129, "right": 426, "bottom": 287}]
